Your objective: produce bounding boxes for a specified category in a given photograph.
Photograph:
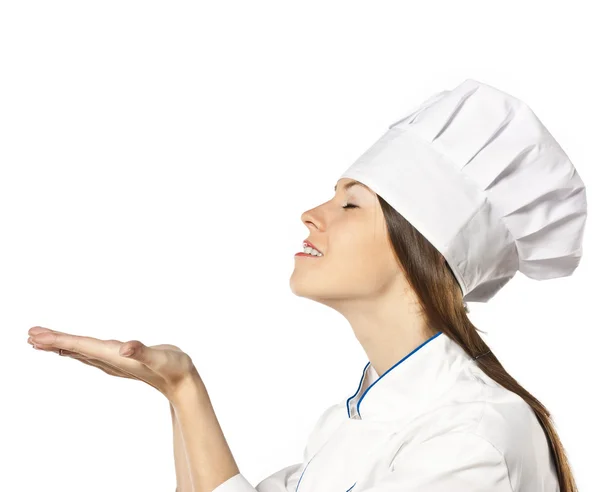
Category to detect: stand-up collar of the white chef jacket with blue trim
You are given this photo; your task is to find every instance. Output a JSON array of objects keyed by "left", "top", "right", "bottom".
[{"left": 346, "top": 331, "right": 473, "bottom": 421}]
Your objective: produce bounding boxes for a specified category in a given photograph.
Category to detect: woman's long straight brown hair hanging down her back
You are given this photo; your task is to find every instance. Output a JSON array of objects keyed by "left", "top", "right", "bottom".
[{"left": 377, "top": 195, "right": 577, "bottom": 492}]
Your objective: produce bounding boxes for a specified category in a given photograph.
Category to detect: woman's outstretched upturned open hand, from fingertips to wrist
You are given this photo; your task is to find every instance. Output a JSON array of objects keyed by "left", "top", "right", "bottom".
[{"left": 27, "top": 326, "right": 201, "bottom": 400}]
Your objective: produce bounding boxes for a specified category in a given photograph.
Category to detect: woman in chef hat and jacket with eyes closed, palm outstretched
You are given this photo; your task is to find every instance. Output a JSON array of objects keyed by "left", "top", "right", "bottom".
[{"left": 29, "top": 79, "right": 587, "bottom": 492}]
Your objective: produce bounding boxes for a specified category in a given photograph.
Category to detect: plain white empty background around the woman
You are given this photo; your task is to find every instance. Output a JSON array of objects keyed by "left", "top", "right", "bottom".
[{"left": 0, "top": 0, "right": 600, "bottom": 492}]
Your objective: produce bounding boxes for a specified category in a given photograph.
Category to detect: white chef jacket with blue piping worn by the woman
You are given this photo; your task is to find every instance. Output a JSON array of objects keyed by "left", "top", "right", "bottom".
[{"left": 213, "top": 332, "right": 559, "bottom": 492}]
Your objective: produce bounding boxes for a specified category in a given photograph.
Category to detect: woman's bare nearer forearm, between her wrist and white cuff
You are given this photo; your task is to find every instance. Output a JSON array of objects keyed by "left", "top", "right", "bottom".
[{"left": 171, "top": 376, "right": 239, "bottom": 492}]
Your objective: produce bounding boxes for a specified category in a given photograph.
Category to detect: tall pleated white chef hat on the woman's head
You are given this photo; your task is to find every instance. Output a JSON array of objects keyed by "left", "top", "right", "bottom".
[{"left": 340, "top": 79, "right": 587, "bottom": 302}]
